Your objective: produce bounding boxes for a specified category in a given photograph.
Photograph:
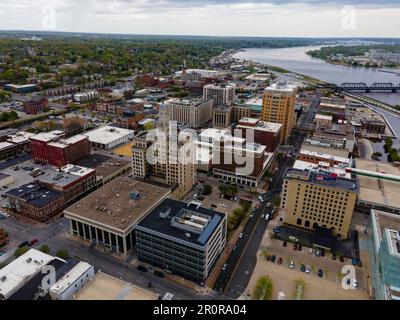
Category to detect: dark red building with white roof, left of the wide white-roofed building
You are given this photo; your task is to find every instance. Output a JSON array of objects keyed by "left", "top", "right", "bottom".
[{"left": 29, "top": 130, "right": 90, "bottom": 167}]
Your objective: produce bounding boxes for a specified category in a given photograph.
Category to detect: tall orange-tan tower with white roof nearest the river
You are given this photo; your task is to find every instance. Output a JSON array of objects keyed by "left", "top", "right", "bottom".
[{"left": 261, "top": 83, "right": 296, "bottom": 142}]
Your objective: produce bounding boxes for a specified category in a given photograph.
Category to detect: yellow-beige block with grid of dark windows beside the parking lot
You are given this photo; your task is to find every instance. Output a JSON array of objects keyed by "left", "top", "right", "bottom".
[{"left": 281, "top": 169, "right": 357, "bottom": 239}]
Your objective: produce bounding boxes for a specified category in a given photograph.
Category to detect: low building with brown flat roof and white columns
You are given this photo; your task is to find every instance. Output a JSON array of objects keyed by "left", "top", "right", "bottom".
[{"left": 64, "top": 177, "right": 171, "bottom": 255}]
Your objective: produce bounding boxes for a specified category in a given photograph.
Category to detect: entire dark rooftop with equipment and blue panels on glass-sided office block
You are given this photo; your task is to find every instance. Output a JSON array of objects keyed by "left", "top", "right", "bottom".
[{"left": 138, "top": 198, "right": 225, "bottom": 246}]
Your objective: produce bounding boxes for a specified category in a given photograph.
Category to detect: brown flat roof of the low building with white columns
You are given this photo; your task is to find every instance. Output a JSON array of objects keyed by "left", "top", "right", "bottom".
[{"left": 64, "top": 177, "right": 170, "bottom": 231}]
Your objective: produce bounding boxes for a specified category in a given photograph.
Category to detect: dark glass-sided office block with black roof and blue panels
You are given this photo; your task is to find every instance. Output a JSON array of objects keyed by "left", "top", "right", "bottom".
[{"left": 136, "top": 199, "right": 227, "bottom": 285}]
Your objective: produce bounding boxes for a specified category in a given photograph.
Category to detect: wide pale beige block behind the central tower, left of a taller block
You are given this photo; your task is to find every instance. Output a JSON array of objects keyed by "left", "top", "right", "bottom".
[{"left": 165, "top": 98, "right": 213, "bottom": 129}]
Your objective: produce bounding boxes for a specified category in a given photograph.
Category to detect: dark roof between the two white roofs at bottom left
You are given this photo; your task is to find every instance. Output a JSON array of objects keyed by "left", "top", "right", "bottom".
[{"left": 9, "top": 258, "right": 79, "bottom": 300}]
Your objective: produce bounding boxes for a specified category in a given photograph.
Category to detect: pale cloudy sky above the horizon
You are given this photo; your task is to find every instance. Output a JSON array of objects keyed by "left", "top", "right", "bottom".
[{"left": 0, "top": 0, "right": 400, "bottom": 37}]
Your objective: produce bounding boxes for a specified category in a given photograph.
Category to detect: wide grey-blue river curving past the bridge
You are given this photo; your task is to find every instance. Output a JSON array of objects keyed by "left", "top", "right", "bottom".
[{"left": 234, "top": 46, "right": 400, "bottom": 105}]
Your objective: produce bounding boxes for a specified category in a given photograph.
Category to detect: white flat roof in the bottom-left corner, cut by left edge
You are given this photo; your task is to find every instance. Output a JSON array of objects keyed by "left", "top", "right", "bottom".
[{"left": 0, "top": 249, "right": 54, "bottom": 299}]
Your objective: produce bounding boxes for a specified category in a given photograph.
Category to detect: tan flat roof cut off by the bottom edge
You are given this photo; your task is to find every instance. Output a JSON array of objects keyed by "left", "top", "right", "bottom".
[{"left": 74, "top": 272, "right": 158, "bottom": 300}]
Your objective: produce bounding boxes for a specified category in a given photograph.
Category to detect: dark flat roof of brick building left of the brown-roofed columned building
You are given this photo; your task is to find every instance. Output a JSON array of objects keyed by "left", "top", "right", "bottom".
[{"left": 7, "top": 182, "right": 63, "bottom": 207}]
